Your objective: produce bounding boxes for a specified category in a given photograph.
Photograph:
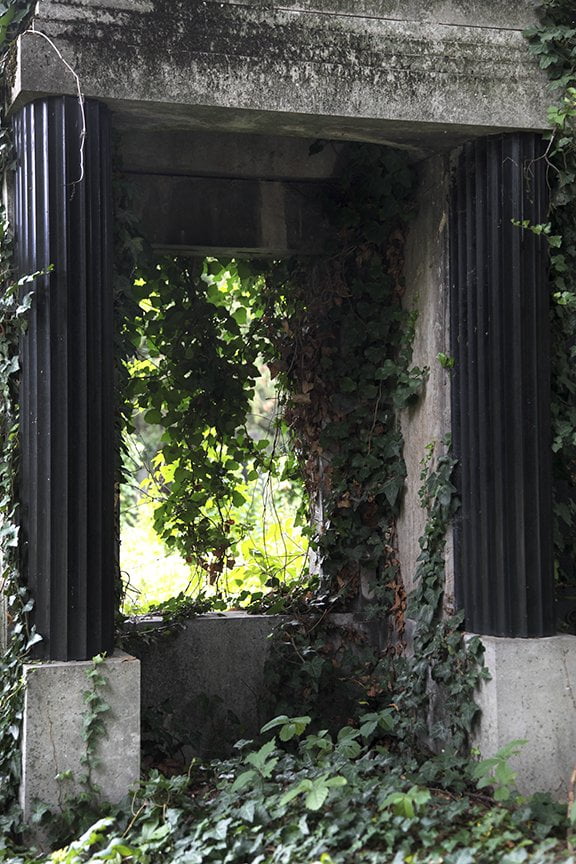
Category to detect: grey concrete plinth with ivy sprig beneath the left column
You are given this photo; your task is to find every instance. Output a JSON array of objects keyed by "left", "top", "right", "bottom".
[{"left": 20, "top": 652, "right": 140, "bottom": 822}]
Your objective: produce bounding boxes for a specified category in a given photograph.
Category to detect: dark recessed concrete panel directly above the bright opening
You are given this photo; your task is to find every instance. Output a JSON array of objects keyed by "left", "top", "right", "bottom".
[{"left": 130, "top": 174, "right": 329, "bottom": 257}]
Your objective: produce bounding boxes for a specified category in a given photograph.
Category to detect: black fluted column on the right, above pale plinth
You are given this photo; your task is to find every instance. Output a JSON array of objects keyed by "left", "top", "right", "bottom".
[{"left": 450, "top": 133, "right": 555, "bottom": 637}]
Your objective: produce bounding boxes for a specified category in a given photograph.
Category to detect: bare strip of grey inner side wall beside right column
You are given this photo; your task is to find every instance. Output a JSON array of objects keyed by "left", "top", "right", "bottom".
[{"left": 397, "top": 156, "right": 454, "bottom": 605}]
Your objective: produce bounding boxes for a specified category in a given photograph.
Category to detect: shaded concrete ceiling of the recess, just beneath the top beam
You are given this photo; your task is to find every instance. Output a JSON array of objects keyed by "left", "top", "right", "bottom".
[{"left": 110, "top": 102, "right": 495, "bottom": 177}]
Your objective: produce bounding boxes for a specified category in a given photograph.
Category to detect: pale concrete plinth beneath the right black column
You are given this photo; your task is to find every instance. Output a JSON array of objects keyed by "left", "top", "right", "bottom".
[{"left": 475, "top": 634, "right": 576, "bottom": 800}]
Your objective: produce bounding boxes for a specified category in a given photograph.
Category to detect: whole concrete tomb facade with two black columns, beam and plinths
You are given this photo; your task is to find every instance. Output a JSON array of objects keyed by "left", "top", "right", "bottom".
[{"left": 8, "top": 0, "right": 576, "bottom": 813}]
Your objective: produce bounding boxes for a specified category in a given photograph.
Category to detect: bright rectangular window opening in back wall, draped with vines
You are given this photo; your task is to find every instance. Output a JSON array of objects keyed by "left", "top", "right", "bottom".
[{"left": 120, "top": 258, "right": 310, "bottom": 615}]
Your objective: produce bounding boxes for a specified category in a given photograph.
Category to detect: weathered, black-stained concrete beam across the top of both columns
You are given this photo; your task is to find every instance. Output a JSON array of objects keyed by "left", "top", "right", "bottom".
[{"left": 13, "top": 0, "right": 548, "bottom": 143}]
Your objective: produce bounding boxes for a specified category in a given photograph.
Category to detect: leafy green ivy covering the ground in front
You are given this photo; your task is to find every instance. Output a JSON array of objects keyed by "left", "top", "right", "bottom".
[{"left": 10, "top": 715, "right": 572, "bottom": 864}]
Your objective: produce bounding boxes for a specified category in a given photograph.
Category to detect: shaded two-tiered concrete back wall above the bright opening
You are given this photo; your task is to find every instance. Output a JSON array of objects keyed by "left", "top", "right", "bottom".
[{"left": 121, "top": 128, "right": 346, "bottom": 257}]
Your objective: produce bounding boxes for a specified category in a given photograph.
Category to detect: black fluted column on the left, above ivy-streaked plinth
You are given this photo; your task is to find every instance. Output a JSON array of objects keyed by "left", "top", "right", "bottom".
[{"left": 13, "top": 96, "right": 115, "bottom": 660}]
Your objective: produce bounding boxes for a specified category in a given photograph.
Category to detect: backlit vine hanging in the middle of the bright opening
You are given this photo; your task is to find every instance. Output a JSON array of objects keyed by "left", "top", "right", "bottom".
[{"left": 125, "top": 259, "right": 267, "bottom": 568}]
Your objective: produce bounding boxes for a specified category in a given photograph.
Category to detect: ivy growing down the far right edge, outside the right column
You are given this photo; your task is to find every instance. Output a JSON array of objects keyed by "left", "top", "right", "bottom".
[{"left": 525, "top": 0, "right": 576, "bottom": 584}]
